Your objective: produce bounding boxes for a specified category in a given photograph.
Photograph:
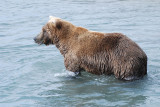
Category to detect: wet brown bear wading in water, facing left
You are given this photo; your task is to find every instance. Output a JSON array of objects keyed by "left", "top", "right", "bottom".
[{"left": 34, "top": 16, "right": 147, "bottom": 80}]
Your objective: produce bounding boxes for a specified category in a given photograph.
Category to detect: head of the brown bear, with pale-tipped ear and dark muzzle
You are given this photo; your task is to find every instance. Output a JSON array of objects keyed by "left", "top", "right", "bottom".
[{"left": 34, "top": 16, "right": 74, "bottom": 45}]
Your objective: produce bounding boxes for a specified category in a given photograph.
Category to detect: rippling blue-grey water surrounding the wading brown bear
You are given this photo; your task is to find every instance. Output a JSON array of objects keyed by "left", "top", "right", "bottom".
[{"left": 0, "top": 0, "right": 160, "bottom": 107}]
